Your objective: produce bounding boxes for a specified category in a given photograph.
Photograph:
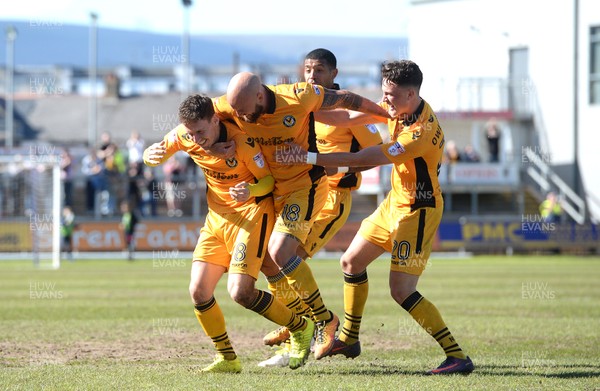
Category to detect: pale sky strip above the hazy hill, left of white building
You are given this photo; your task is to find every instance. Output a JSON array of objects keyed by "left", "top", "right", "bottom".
[{"left": 0, "top": 0, "right": 408, "bottom": 37}]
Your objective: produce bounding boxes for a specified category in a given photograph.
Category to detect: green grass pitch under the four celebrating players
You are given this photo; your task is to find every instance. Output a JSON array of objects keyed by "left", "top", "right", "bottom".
[{"left": 0, "top": 256, "right": 600, "bottom": 390}]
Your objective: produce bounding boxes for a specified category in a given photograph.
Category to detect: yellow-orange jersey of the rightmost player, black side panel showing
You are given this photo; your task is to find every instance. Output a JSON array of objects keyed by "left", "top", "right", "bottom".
[{"left": 380, "top": 100, "right": 445, "bottom": 210}]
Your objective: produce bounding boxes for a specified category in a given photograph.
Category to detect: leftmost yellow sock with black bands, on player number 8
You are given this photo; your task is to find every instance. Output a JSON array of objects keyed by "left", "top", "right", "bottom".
[{"left": 194, "top": 296, "right": 237, "bottom": 360}]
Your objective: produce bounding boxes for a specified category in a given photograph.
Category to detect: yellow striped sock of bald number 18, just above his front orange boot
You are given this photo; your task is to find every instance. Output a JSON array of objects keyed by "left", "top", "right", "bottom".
[{"left": 281, "top": 256, "right": 331, "bottom": 322}]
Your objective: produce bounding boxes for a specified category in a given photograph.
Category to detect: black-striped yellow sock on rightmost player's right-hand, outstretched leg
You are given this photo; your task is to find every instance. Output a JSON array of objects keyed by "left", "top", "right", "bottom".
[{"left": 402, "top": 291, "right": 467, "bottom": 359}]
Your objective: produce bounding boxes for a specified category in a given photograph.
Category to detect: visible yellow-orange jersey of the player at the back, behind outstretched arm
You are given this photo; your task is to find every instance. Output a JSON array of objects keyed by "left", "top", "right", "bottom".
[{"left": 315, "top": 122, "right": 383, "bottom": 190}]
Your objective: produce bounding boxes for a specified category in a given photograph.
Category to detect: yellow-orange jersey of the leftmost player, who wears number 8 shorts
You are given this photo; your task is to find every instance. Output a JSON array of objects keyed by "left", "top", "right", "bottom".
[{"left": 163, "top": 122, "right": 271, "bottom": 213}]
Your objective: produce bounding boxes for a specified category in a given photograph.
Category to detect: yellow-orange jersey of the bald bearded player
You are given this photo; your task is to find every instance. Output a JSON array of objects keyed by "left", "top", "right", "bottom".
[{"left": 213, "top": 83, "right": 325, "bottom": 195}]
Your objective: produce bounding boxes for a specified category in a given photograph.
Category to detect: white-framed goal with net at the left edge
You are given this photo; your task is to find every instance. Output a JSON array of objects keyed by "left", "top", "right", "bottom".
[{"left": 0, "top": 153, "right": 61, "bottom": 268}]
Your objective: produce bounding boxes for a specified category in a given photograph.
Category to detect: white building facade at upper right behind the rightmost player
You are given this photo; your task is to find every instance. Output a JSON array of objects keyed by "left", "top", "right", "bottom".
[{"left": 407, "top": 0, "right": 600, "bottom": 220}]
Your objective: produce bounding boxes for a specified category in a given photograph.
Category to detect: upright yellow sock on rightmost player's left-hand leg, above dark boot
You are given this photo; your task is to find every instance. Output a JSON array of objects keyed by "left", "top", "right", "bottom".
[{"left": 339, "top": 270, "right": 369, "bottom": 345}]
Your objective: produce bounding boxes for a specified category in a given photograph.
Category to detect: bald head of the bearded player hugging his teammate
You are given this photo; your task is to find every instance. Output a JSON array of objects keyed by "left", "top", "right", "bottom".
[{"left": 227, "top": 72, "right": 264, "bottom": 122}]
